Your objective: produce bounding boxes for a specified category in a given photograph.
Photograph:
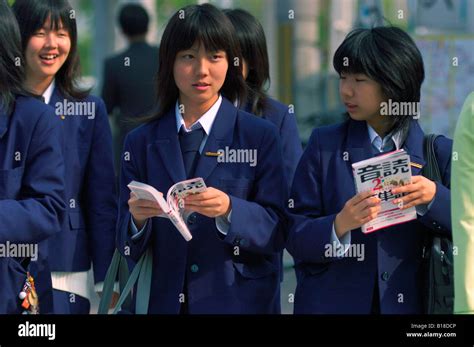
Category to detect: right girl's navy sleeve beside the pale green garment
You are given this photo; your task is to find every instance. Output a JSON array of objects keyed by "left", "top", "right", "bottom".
[{"left": 419, "top": 137, "right": 452, "bottom": 235}]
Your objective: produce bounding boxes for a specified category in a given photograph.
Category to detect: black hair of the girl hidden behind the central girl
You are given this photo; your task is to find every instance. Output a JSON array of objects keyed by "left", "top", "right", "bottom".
[{"left": 224, "top": 9, "right": 270, "bottom": 116}]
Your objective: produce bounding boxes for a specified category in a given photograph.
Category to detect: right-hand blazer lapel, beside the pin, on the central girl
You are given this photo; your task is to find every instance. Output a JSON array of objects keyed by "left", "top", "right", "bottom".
[{"left": 194, "top": 98, "right": 237, "bottom": 180}]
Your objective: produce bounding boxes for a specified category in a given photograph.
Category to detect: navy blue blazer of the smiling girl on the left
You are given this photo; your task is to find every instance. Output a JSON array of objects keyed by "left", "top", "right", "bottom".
[{"left": 48, "top": 88, "right": 117, "bottom": 282}]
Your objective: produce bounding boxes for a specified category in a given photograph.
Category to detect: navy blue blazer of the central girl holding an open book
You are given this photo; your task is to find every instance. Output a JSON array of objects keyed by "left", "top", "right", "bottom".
[{"left": 117, "top": 98, "right": 288, "bottom": 314}]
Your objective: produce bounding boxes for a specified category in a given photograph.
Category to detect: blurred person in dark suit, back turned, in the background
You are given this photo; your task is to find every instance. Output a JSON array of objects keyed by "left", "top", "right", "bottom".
[{"left": 102, "top": 4, "right": 158, "bottom": 172}]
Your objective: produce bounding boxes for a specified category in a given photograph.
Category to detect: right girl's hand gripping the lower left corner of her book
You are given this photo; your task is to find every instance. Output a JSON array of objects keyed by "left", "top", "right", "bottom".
[{"left": 334, "top": 190, "right": 381, "bottom": 238}]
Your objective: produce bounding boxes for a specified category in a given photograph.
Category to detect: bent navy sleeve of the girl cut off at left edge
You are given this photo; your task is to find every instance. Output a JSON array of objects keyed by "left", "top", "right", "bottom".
[{"left": 0, "top": 109, "right": 66, "bottom": 243}]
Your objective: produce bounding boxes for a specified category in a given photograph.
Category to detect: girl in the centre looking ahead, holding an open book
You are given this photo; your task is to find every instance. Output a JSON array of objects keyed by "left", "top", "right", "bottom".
[{"left": 118, "top": 4, "right": 287, "bottom": 314}]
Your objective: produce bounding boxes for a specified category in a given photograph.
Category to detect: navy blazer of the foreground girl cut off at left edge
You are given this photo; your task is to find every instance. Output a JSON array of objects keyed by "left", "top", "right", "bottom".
[{"left": 0, "top": 96, "right": 66, "bottom": 313}]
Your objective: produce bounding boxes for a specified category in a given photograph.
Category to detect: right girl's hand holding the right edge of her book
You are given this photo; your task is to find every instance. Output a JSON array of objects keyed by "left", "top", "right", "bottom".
[{"left": 392, "top": 176, "right": 436, "bottom": 210}]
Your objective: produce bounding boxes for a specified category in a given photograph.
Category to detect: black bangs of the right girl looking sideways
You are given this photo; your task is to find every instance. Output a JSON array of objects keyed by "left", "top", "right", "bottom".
[{"left": 333, "top": 30, "right": 378, "bottom": 80}]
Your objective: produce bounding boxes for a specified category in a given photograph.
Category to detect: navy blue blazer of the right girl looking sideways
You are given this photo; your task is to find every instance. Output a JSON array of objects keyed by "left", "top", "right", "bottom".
[{"left": 287, "top": 120, "right": 452, "bottom": 314}]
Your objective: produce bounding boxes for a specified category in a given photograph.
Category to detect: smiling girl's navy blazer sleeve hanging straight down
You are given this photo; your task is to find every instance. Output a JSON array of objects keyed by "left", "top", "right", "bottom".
[{"left": 84, "top": 100, "right": 117, "bottom": 283}]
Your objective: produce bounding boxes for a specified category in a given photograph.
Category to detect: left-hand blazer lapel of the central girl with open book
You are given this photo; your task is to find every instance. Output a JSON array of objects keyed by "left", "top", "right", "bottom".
[{"left": 151, "top": 108, "right": 186, "bottom": 183}]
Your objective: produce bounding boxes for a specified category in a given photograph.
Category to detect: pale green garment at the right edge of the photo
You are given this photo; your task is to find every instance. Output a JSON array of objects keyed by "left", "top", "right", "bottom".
[{"left": 451, "top": 93, "right": 474, "bottom": 313}]
